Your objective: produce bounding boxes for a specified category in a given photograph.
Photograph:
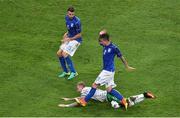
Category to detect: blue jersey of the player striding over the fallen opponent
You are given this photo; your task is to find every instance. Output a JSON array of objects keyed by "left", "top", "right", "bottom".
[{"left": 103, "top": 43, "right": 122, "bottom": 72}]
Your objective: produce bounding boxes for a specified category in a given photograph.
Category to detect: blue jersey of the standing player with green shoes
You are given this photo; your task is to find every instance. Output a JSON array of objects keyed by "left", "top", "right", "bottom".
[{"left": 65, "top": 16, "right": 82, "bottom": 43}]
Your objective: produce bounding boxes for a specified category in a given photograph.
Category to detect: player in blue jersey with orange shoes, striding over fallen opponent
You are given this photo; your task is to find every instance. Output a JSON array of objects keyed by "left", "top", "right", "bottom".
[{"left": 77, "top": 30, "right": 135, "bottom": 109}]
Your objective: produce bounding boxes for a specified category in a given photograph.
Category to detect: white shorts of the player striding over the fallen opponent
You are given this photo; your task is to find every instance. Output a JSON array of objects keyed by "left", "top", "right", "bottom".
[{"left": 95, "top": 70, "right": 116, "bottom": 88}]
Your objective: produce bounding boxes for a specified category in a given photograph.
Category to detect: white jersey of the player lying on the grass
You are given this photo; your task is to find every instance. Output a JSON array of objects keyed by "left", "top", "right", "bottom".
[{"left": 81, "top": 87, "right": 107, "bottom": 102}]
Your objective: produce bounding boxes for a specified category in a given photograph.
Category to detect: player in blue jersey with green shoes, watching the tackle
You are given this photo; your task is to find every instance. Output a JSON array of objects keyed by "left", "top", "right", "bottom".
[{"left": 57, "top": 7, "right": 82, "bottom": 80}]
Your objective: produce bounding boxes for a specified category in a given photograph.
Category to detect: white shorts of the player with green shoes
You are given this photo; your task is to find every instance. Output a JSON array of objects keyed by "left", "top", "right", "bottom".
[{"left": 59, "top": 40, "right": 80, "bottom": 56}]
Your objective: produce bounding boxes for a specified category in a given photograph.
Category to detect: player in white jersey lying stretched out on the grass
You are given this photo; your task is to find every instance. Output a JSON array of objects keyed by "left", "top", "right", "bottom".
[{"left": 58, "top": 82, "right": 155, "bottom": 108}]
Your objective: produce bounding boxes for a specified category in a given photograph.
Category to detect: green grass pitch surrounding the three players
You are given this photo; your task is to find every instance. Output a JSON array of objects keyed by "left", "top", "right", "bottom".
[{"left": 0, "top": 0, "right": 180, "bottom": 117}]
